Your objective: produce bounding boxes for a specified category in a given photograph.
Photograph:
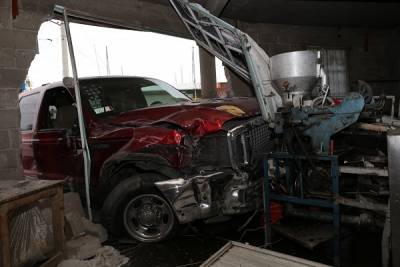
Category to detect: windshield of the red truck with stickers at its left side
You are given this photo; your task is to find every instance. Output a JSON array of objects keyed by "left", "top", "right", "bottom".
[{"left": 79, "top": 78, "right": 190, "bottom": 117}]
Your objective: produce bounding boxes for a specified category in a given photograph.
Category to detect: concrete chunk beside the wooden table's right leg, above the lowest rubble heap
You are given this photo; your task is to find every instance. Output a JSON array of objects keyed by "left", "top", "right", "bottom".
[{"left": 66, "top": 235, "right": 101, "bottom": 260}]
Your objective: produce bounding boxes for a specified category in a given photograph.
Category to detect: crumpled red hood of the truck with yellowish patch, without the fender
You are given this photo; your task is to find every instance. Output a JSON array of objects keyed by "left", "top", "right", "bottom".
[{"left": 110, "top": 98, "right": 260, "bottom": 135}]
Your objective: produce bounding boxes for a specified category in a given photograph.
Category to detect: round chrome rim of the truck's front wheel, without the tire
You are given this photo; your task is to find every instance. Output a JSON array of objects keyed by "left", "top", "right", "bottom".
[{"left": 124, "top": 194, "right": 174, "bottom": 242}]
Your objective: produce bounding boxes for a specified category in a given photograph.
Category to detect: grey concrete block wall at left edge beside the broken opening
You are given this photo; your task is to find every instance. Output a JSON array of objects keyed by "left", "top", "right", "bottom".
[{"left": 0, "top": 0, "right": 50, "bottom": 180}]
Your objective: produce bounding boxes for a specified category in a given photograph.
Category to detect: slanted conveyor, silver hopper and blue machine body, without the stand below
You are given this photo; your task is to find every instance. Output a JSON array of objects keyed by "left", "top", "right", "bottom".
[{"left": 171, "top": 1, "right": 364, "bottom": 154}]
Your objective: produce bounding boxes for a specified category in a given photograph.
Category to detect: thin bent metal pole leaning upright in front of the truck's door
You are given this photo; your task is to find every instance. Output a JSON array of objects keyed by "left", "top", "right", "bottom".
[{"left": 58, "top": 7, "right": 93, "bottom": 221}]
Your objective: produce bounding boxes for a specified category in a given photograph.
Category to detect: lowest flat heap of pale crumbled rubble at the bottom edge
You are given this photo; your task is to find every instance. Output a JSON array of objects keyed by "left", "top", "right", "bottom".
[{"left": 58, "top": 246, "right": 129, "bottom": 267}]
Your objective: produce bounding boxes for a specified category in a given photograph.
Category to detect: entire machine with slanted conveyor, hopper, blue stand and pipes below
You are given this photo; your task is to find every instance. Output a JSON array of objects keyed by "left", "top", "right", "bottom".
[{"left": 170, "top": 0, "right": 398, "bottom": 266}]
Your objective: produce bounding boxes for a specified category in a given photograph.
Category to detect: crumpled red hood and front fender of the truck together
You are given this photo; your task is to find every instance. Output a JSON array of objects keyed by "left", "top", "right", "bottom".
[{"left": 89, "top": 98, "right": 260, "bottom": 167}]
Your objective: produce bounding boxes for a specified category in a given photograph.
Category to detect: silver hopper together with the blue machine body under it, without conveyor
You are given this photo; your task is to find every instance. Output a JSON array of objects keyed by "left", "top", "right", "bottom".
[{"left": 271, "top": 51, "right": 364, "bottom": 154}]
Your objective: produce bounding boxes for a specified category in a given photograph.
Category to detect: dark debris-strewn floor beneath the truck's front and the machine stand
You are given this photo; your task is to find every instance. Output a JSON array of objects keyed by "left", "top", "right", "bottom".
[{"left": 103, "top": 216, "right": 380, "bottom": 267}]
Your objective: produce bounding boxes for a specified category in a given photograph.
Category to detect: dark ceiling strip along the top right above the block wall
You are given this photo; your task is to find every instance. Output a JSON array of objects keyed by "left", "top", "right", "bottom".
[{"left": 145, "top": 0, "right": 400, "bottom": 27}]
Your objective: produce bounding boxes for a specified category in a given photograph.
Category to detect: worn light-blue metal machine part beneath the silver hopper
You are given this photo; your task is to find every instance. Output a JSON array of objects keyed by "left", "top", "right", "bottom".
[{"left": 291, "top": 93, "right": 364, "bottom": 154}]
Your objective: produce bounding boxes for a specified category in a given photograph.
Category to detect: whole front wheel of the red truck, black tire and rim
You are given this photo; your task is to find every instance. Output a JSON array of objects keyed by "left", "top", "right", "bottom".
[{"left": 102, "top": 173, "right": 178, "bottom": 242}]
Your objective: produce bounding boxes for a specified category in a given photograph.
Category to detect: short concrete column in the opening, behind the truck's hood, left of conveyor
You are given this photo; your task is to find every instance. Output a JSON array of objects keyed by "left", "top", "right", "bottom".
[{"left": 199, "top": 48, "right": 217, "bottom": 98}]
